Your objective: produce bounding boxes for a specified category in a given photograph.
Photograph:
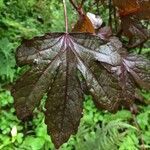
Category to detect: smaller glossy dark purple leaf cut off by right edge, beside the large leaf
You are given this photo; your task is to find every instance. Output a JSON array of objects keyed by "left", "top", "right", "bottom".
[{"left": 104, "top": 50, "right": 150, "bottom": 105}]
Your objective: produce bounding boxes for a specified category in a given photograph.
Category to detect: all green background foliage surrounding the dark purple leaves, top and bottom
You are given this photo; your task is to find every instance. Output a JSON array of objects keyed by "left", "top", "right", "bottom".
[{"left": 0, "top": 0, "right": 150, "bottom": 150}]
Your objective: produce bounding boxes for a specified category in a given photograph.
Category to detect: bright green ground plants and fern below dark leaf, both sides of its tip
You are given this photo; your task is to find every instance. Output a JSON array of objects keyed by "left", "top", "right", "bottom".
[{"left": 0, "top": 91, "right": 150, "bottom": 150}]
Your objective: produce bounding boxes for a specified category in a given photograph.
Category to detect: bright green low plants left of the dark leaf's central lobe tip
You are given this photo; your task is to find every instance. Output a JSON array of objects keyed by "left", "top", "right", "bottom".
[{"left": 0, "top": 91, "right": 53, "bottom": 150}]
